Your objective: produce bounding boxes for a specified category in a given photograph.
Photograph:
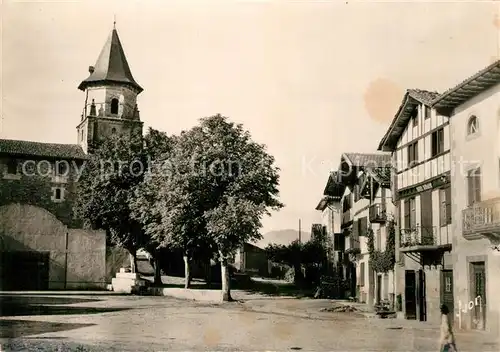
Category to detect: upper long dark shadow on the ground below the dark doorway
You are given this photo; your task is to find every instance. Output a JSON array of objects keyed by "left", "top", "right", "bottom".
[{"left": 0, "top": 296, "right": 129, "bottom": 317}]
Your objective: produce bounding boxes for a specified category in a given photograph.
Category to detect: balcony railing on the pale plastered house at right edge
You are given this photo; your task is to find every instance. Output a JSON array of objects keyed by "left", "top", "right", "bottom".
[{"left": 462, "top": 198, "right": 500, "bottom": 236}]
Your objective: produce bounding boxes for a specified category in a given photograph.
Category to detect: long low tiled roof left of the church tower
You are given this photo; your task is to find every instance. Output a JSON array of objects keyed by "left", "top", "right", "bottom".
[{"left": 0, "top": 139, "right": 87, "bottom": 160}]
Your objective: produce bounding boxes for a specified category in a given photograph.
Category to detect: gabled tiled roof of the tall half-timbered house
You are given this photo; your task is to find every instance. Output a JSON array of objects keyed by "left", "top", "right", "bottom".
[{"left": 378, "top": 89, "right": 439, "bottom": 151}]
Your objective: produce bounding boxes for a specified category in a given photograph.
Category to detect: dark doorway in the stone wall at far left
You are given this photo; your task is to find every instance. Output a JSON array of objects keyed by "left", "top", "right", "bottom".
[{"left": 0, "top": 251, "right": 49, "bottom": 291}]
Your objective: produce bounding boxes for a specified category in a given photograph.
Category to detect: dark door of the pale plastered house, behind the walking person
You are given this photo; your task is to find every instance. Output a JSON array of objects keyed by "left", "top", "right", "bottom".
[{"left": 470, "top": 262, "right": 487, "bottom": 330}]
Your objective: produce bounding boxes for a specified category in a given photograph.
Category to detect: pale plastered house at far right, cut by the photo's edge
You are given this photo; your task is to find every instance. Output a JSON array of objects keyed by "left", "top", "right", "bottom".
[{"left": 434, "top": 61, "right": 500, "bottom": 336}]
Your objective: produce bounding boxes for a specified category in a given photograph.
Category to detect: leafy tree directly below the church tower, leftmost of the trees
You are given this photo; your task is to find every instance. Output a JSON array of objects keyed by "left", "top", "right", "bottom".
[{"left": 75, "top": 135, "right": 147, "bottom": 272}]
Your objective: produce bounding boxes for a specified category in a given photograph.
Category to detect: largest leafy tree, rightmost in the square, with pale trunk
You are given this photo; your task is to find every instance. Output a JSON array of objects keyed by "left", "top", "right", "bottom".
[{"left": 179, "top": 115, "right": 283, "bottom": 301}]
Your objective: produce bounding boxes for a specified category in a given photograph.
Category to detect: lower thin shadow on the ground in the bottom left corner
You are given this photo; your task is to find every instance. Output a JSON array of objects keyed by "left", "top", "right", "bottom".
[{"left": 0, "top": 320, "right": 95, "bottom": 339}]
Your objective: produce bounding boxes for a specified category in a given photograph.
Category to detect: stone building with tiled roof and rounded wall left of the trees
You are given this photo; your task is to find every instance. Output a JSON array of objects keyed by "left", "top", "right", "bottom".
[{"left": 0, "top": 139, "right": 106, "bottom": 290}]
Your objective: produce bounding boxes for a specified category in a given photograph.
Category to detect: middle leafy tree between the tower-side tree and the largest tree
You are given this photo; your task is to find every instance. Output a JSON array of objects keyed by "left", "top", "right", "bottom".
[{"left": 131, "top": 129, "right": 215, "bottom": 288}]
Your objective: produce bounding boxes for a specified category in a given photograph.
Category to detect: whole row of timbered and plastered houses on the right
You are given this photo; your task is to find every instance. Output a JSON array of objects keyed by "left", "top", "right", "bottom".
[{"left": 316, "top": 61, "right": 500, "bottom": 332}]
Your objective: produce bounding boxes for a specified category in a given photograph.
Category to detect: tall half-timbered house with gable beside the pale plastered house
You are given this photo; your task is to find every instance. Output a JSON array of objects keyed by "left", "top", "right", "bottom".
[{"left": 378, "top": 89, "right": 453, "bottom": 321}]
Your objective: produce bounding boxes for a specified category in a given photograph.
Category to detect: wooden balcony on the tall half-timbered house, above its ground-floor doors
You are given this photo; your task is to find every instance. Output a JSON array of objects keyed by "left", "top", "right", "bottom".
[{"left": 399, "top": 226, "right": 451, "bottom": 252}]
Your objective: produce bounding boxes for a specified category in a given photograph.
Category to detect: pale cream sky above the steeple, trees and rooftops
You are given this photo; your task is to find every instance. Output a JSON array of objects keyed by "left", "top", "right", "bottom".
[{"left": 0, "top": 0, "right": 500, "bottom": 236}]
